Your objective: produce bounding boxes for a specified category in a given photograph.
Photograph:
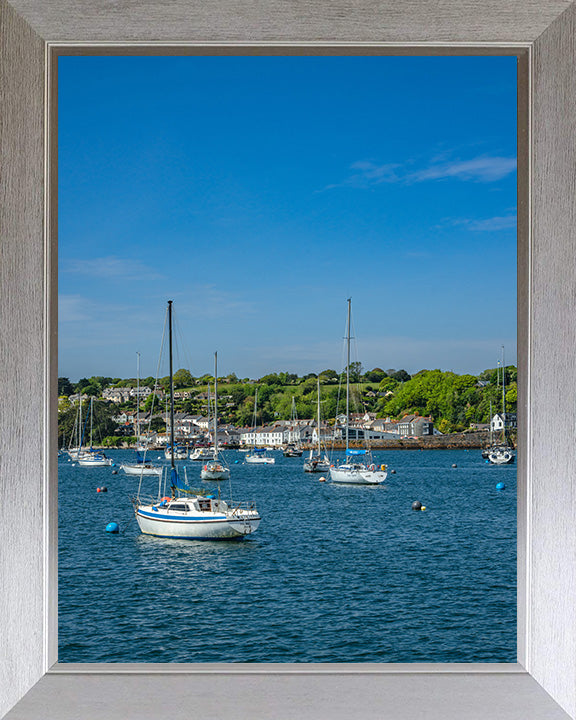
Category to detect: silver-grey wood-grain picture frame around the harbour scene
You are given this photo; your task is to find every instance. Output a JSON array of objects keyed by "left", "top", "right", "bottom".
[{"left": 0, "top": 0, "right": 576, "bottom": 720}]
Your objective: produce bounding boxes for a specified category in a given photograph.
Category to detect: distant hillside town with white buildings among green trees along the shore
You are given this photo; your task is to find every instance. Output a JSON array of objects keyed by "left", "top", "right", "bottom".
[{"left": 58, "top": 363, "right": 517, "bottom": 448}]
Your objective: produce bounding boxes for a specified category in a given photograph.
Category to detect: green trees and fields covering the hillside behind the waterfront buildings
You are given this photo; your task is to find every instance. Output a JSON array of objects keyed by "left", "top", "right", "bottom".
[{"left": 58, "top": 362, "right": 517, "bottom": 434}]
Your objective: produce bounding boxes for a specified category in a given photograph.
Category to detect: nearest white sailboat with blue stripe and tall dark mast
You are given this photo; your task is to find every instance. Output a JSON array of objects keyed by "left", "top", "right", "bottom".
[{"left": 133, "top": 300, "right": 260, "bottom": 540}]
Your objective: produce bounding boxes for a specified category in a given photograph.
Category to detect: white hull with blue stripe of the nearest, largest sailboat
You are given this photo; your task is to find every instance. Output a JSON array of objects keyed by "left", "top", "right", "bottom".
[{"left": 136, "top": 508, "right": 260, "bottom": 540}]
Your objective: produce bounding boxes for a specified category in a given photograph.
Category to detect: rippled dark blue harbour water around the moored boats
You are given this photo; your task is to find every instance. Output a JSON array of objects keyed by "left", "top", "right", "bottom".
[{"left": 59, "top": 450, "right": 516, "bottom": 663}]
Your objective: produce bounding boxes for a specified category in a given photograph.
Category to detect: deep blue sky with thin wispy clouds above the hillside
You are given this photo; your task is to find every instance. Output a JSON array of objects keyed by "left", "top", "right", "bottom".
[{"left": 58, "top": 57, "right": 516, "bottom": 380}]
